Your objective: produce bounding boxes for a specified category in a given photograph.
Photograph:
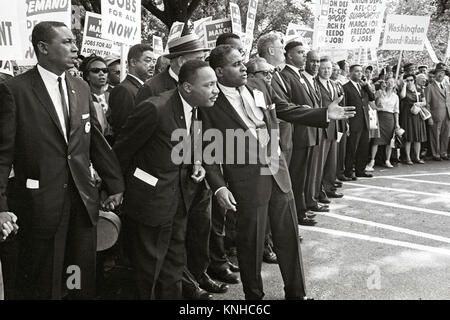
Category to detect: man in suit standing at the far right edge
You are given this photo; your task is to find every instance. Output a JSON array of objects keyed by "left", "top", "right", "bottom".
[{"left": 425, "top": 68, "right": 450, "bottom": 161}]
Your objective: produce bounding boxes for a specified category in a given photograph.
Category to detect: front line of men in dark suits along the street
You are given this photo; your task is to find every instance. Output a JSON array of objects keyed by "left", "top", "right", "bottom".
[{"left": 0, "top": 22, "right": 450, "bottom": 300}]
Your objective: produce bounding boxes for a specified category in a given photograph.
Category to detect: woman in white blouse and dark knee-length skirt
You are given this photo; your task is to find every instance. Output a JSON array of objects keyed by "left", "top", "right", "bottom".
[{"left": 366, "top": 78, "right": 400, "bottom": 170}]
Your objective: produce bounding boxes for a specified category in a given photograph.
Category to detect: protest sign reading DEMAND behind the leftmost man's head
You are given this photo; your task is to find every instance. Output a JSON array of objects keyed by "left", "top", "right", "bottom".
[{"left": 17, "top": 0, "right": 72, "bottom": 65}]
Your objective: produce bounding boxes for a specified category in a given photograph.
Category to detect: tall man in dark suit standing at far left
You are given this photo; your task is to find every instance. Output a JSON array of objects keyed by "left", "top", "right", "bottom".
[{"left": 0, "top": 22, "right": 124, "bottom": 299}]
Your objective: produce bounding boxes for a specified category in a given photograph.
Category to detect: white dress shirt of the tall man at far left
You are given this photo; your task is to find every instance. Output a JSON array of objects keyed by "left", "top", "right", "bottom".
[{"left": 37, "top": 64, "right": 70, "bottom": 142}]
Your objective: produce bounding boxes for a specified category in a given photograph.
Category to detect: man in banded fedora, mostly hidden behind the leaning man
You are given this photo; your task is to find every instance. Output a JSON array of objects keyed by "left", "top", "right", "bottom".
[{"left": 136, "top": 34, "right": 223, "bottom": 300}]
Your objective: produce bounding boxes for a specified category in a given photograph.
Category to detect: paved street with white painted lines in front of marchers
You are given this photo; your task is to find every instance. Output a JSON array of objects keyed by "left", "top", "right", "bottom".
[{"left": 215, "top": 161, "right": 450, "bottom": 300}]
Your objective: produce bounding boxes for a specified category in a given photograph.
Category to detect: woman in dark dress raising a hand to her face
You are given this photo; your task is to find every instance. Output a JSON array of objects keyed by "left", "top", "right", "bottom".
[{"left": 400, "top": 74, "right": 427, "bottom": 165}]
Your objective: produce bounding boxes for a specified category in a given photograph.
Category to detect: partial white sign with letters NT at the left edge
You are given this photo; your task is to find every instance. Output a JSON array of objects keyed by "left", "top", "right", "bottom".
[{"left": 0, "top": 0, "right": 25, "bottom": 60}]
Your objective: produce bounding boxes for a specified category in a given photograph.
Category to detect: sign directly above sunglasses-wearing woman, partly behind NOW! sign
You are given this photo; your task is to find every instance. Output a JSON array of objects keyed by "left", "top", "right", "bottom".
[{"left": 80, "top": 12, "right": 120, "bottom": 57}]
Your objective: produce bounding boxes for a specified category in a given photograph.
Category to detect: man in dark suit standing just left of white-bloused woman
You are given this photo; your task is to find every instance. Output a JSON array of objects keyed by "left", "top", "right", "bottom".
[{"left": 343, "top": 65, "right": 375, "bottom": 180}]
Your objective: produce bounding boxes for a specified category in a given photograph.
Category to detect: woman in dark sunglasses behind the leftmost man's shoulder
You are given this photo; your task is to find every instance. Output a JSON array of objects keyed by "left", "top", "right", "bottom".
[{"left": 80, "top": 56, "right": 112, "bottom": 139}]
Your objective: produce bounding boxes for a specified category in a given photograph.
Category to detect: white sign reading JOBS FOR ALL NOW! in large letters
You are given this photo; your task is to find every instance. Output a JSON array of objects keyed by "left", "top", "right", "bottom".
[{"left": 101, "top": 0, "right": 141, "bottom": 46}]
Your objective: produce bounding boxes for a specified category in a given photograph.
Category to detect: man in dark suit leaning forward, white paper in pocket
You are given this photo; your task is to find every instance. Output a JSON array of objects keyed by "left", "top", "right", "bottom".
[{"left": 114, "top": 61, "right": 218, "bottom": 299}]
